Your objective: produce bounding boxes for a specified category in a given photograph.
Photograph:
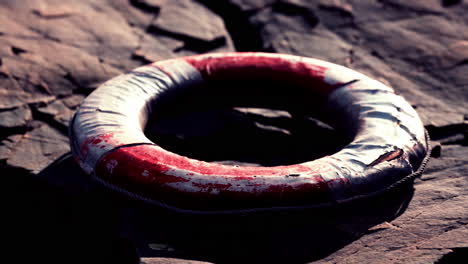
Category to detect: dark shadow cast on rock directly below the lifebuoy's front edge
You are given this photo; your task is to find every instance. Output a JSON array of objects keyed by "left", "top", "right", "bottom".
[{"left": 124, "top": 182, "right": 413, "bottom": 263}]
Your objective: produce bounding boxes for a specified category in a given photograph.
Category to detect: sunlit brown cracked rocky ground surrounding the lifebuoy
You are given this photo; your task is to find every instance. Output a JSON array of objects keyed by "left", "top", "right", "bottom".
[{"left": 0, "top": 0, "right": 468, "bottom": 264}]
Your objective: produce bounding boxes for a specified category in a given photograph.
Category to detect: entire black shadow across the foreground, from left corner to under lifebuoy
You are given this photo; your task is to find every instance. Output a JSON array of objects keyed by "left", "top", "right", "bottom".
[{"left": 8, "top": 151, "right": 413, "bottom": 263}]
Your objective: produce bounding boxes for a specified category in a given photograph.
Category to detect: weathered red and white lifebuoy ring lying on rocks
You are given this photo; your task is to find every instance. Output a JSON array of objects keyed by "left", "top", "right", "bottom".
[{"left": 70, "top": 53, "right": 429, "bottom": 212}]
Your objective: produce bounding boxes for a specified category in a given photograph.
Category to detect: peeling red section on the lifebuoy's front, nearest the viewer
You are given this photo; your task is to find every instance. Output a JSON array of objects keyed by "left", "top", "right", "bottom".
[{"left": 92, "top": 145, "right": 336, "bottom": 207}]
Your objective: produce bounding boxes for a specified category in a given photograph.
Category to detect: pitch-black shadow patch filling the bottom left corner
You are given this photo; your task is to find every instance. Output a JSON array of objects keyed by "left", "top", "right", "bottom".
[{"left": 5, "top": 157, "right": 139, "bottom": 263}]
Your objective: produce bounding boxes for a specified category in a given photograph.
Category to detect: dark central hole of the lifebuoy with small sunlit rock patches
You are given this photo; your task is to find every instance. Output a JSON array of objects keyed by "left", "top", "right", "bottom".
[{"left": 144, "top": 75, "right": 352, "bottom": 166}]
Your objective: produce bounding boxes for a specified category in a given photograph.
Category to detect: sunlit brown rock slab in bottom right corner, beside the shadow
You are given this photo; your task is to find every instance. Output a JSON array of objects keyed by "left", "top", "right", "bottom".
[{"left": 317, "top": 145, "right": 468, "bottom": 263}]
